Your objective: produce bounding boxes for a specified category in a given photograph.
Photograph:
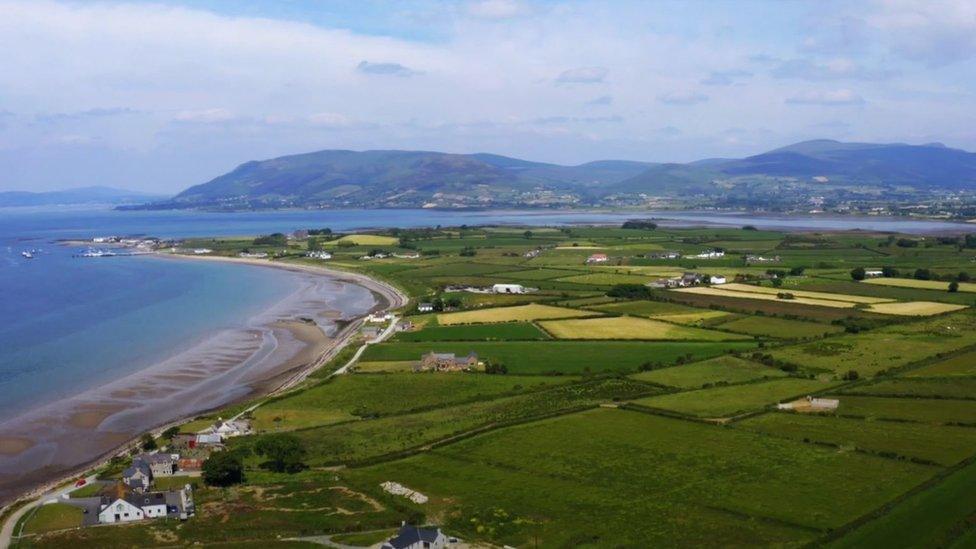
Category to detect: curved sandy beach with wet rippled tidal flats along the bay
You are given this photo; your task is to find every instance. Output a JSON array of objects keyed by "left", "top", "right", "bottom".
[{"left": 0, "top": 254, "right": 406, "bottom": 506}]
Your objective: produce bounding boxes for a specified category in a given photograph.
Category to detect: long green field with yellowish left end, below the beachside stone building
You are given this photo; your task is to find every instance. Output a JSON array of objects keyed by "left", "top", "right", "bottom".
[{"left": 254, "top": 373, "right": 562, "bottom": 431}]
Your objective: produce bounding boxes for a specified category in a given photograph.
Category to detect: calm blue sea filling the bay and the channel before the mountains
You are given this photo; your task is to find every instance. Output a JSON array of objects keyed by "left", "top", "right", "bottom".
[{"left": 0, "top": 209, "right": 976, "bottom": 420}]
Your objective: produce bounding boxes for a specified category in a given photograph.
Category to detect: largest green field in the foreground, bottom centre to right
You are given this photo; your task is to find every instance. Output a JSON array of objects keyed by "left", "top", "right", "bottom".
[{"left": 354, "top": 409, "right": 931, "bottom": 547}]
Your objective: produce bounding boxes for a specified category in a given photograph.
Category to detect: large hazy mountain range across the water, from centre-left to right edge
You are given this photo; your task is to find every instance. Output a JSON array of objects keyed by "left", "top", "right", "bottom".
[{"left": 126, "top": 140, "right": 976, "bottom": 209}]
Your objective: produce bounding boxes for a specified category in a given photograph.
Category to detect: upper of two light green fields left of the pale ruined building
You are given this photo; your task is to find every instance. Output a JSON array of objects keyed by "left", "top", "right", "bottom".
[{"left": 631, "top": 356, "right": 786, "bottom": 389}]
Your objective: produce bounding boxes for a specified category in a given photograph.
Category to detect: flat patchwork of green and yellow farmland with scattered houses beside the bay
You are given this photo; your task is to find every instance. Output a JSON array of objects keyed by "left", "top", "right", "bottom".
[{"left": 16, "top": 223, "right": 976, "bottom": 549}]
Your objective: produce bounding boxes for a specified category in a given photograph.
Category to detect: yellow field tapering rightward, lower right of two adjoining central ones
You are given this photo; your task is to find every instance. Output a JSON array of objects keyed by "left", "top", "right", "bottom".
[{"left": 540, "top": 316, "right": 750, "bottom": 341}]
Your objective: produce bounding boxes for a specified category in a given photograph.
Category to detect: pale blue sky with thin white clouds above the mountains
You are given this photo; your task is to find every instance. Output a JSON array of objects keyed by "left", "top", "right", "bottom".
[{"left": 0, "top": 0, "right": 976, "bottom": 192}]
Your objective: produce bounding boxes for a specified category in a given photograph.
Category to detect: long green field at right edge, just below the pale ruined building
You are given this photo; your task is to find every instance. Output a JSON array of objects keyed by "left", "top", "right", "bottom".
[{"left": 736, "top": 413, "right": 976, "bottom": 466}]
